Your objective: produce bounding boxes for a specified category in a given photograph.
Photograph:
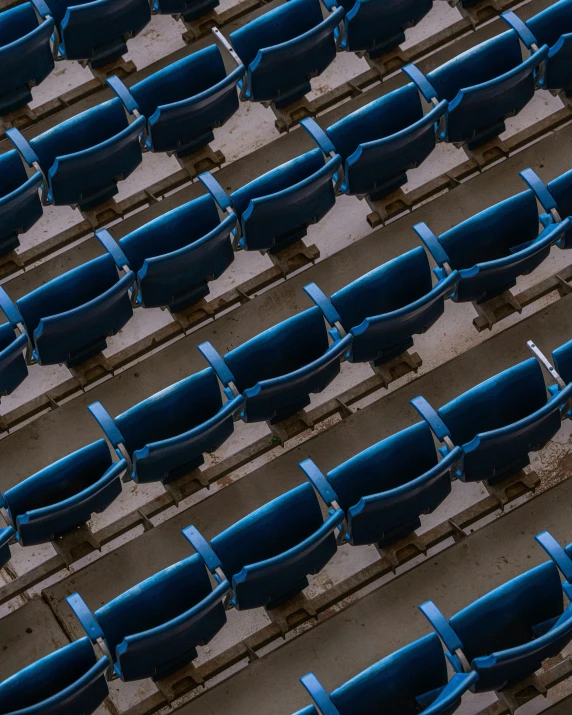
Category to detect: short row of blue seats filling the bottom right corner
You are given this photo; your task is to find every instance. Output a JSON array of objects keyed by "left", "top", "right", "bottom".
[{"left": 296, "top": 532, "right": 572, "bottom": 715}]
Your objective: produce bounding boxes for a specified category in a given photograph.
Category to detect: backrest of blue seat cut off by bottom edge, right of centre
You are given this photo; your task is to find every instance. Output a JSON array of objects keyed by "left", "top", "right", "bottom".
[{"left": 330, "top": 633, "right": 448, "bottom": 715}]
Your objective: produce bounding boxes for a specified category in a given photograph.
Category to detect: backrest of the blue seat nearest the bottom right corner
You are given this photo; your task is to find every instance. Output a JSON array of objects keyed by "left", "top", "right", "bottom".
[{"left": 450, "top": 562, "right": 563, "bottom": 661}]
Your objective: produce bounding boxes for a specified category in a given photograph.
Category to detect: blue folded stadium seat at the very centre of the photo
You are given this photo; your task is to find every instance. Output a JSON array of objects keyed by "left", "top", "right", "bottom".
[{"left": 199, "top": 307, "right": 352, "bottom": 423}]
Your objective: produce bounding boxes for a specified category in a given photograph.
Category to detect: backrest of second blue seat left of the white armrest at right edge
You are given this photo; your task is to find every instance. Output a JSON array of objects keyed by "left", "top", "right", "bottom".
[{"left": 328, "top": 422, "right": 437, "bottom": 512}]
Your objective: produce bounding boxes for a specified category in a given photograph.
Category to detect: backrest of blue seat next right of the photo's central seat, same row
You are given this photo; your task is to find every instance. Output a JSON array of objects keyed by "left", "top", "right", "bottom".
[{"left": 330, "top": 246, "right": 432, "bottom": 331}]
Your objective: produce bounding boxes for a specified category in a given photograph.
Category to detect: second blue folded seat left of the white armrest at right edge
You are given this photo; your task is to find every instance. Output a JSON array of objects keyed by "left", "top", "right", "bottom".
[{"left": 300, "top": 422, "right": 463, "bottom": 547}]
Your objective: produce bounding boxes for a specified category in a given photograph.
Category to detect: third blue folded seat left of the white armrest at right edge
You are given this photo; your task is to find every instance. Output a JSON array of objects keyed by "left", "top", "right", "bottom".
[{"left": 183, "top": 482, "right": 344, "bottom": 610}]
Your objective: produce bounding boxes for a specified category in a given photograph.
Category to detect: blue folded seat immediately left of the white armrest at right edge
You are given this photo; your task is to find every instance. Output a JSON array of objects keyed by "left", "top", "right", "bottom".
[{"left": 411, "top": 358, "right": 572, "bottom": 482}]
